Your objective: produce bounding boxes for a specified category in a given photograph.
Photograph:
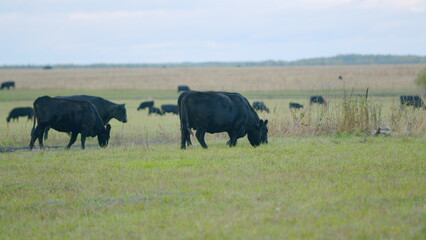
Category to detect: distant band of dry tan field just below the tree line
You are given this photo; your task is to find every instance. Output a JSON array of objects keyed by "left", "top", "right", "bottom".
[{"left": 0, "top": 65, "right": 426, "bottom": 92}]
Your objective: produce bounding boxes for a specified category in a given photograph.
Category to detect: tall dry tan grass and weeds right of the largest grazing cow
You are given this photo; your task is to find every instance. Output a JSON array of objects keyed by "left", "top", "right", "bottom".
[{"left": 269, "top": 92, "right": 426, "bottom": 136}]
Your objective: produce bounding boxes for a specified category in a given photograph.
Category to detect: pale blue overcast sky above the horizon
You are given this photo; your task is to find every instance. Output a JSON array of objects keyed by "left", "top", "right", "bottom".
[{"left": 0, "top": 0, "right": 426, "bottom": 65}]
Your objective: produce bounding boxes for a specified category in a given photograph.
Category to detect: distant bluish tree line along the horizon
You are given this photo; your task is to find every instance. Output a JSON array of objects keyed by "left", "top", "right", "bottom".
[{"left": 0, "top": 54, "right": 426, "bottom": 70}]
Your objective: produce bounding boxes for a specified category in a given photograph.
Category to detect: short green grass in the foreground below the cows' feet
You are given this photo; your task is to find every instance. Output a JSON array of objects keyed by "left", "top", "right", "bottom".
[{"left": 0, "top": 137, "right": 426, "bottom": 239}]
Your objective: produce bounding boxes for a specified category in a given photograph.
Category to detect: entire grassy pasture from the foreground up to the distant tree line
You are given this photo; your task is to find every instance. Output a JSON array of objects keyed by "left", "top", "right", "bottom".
[{"left": 0, "top": 65, "right": 426, "bottom": 239}]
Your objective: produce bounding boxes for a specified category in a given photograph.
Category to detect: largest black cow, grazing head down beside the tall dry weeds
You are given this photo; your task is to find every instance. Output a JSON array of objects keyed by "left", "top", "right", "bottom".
[{"left": 178, "top": 91, "right": 268, "bottom": 149}]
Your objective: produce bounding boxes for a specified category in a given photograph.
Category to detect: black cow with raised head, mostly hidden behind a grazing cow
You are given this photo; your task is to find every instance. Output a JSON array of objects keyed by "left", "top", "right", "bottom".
[{"left": 44, "top": 95, "right": 127, "bottom": 139}]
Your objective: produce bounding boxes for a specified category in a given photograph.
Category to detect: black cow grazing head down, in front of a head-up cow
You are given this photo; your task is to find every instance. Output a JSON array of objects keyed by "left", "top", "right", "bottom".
[{"left": 30, "top": 96, "right": 111, "bottom": 149}]
